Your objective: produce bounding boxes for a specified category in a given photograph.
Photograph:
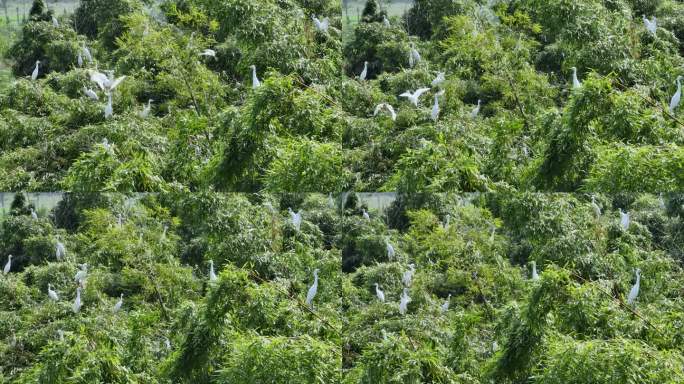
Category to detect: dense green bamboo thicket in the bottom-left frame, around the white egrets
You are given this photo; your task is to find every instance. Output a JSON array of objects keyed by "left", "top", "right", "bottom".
[{"left": 0, "top": 194, "right": 342, "bottom": 383}]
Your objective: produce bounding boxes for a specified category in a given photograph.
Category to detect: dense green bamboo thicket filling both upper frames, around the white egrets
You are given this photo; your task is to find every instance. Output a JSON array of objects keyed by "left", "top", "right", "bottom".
[{"left": 0, "top": 0, "right": 684, "bottom": 192}]
